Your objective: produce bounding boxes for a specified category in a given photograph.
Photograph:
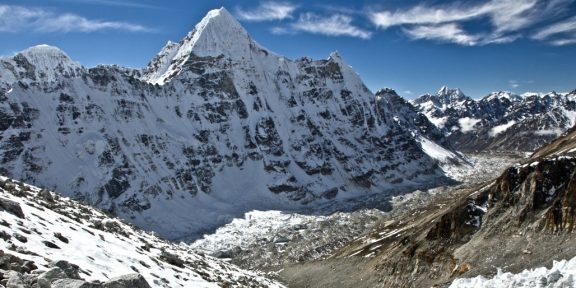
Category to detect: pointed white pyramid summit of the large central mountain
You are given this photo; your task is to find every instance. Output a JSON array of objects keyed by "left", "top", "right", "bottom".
[{"left": 143, "top": 7, "right": 269, "bottom": 84}]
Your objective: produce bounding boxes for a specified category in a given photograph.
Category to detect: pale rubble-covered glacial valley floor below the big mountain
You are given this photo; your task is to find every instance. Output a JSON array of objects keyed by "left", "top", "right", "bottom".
[{"left": 190, "top": 154, "right": 523, "bottom": 287}]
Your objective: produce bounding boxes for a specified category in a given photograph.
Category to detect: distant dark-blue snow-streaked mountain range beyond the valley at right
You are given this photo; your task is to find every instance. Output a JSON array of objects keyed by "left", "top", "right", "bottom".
[{"left": 412, "top": 87, "right": 576, "bottom": 152}]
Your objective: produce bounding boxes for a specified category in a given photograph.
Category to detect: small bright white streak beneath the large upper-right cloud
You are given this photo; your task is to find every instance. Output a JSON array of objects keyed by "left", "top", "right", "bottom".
[{"left": 404, "top": 23, "right": 480, "bottom": 46}]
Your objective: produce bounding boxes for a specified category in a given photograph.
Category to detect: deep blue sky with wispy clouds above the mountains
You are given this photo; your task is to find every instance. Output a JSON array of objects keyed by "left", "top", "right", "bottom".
[{"left": 0, "top": 0, "right": 576, "bottom": 98}]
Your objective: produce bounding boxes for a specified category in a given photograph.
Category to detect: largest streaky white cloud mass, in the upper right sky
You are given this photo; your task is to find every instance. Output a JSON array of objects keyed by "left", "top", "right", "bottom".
[{"left": 369, "top": 0, "right": 574, "bottom": 46}]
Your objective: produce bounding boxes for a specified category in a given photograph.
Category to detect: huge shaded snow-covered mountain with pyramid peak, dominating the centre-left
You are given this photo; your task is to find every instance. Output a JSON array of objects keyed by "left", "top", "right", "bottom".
[{"left": 0, "top": 8, "right": 459, "bottom": 239}]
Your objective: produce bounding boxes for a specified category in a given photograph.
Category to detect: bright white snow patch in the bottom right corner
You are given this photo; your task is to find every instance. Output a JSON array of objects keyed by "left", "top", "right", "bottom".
[{"left": 450, "top": 257, "right": 576, "bottom": 288}]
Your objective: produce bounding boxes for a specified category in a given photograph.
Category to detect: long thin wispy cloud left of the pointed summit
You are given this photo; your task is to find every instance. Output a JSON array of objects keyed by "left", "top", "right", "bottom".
[{"left": 0, "top": 5, "right": 152, "bottom": 33}]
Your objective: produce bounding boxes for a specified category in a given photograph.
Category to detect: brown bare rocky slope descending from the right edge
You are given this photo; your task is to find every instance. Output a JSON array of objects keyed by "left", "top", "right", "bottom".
[{"left": 282, "top": 129, "right": 576, "bottom": 287}]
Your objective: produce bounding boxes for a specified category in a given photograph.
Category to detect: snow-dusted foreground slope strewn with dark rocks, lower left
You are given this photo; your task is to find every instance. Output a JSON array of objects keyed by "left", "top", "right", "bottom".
[{"left": 0, "top": 177, "right": 283, "bottom": 287}]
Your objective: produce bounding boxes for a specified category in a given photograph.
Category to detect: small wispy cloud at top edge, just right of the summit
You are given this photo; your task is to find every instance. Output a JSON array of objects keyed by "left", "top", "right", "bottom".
[{"left": 236, "top": 2, "right": 298, "bottom": 22}]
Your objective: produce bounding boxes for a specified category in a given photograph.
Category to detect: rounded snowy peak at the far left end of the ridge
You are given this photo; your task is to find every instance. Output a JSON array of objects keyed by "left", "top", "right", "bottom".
[{"left": 0, "top": 45, "right": 85, "bottom": 89}]
